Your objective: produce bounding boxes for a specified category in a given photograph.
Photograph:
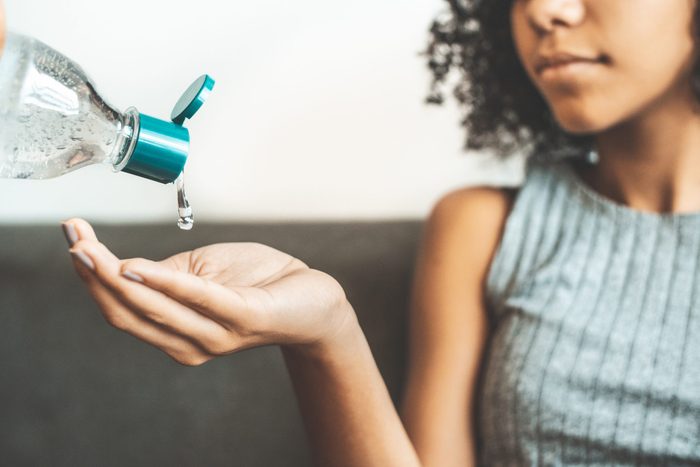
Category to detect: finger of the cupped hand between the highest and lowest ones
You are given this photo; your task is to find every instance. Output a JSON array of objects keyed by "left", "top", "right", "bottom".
[{"left": 71, "top": 240, "right": 238, "bottom": 355}]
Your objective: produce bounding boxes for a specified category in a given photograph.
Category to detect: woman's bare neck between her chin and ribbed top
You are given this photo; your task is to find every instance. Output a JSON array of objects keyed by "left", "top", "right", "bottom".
[{"left": 583, "top": 83, "right": 700, "bottom": 212}]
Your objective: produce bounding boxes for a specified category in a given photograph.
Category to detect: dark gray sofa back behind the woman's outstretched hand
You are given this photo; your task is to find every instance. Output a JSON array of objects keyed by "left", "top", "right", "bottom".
[{"left": 0, "top": 220, "right": 422, "bottom": 467}]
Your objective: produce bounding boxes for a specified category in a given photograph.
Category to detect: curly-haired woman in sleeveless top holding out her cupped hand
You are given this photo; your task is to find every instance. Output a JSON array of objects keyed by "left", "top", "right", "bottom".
[{"left": 54, "top": 0, "right": 700, "bottom": 467}]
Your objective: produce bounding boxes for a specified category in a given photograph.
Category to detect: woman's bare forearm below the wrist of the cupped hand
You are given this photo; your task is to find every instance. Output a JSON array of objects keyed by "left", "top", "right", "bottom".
[{"left": 282, "top": 304, "right": 420, "bottom": 467}]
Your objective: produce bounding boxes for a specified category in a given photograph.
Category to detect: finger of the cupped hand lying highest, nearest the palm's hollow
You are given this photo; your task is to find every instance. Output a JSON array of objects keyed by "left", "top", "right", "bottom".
[{"left": 122, "top": 259, "right": 264, "bottom": 329}]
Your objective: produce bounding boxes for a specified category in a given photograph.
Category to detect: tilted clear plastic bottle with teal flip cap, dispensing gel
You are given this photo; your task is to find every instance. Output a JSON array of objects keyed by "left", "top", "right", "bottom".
[{"left": 0, "top": 33, "right": 214, "bottom": 229}]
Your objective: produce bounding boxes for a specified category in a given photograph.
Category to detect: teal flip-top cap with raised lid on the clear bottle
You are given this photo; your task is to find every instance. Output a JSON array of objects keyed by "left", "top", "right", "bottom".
[{"left": 122, "top": 75, "right": 214, "bottom": 183}]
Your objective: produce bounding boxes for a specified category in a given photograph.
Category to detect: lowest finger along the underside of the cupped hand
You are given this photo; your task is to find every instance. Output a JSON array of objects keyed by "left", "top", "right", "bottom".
[{"left": 67, "top": 245, "right": 211, "bottom": 366}]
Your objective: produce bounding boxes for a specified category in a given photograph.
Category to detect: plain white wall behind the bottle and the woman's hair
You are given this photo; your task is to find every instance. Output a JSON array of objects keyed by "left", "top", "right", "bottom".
[{"left": 0, "top": 0, "right": 521, "bottom": 222}]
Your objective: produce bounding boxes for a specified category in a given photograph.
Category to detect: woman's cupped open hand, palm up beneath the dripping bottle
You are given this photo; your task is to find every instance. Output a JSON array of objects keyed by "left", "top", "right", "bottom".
[{"left": 63, "top": 219, "right": 356, "bottom": 365}]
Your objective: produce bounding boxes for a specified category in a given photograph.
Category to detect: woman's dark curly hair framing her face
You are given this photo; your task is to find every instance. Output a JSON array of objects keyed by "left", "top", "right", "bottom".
[{"left": 423, "top": 0, "right": 700, "bottom": 159}]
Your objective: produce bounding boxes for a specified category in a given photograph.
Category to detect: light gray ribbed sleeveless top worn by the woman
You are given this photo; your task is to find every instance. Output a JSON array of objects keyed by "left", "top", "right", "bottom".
[{"left": 477, "top": 161, "right": 700, "bottom": 466}]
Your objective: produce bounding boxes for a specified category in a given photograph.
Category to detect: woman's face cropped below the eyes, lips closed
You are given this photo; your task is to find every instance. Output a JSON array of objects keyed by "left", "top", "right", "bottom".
[{"left": 511, "top": 0, "right": 695, "bottom": 133}]
